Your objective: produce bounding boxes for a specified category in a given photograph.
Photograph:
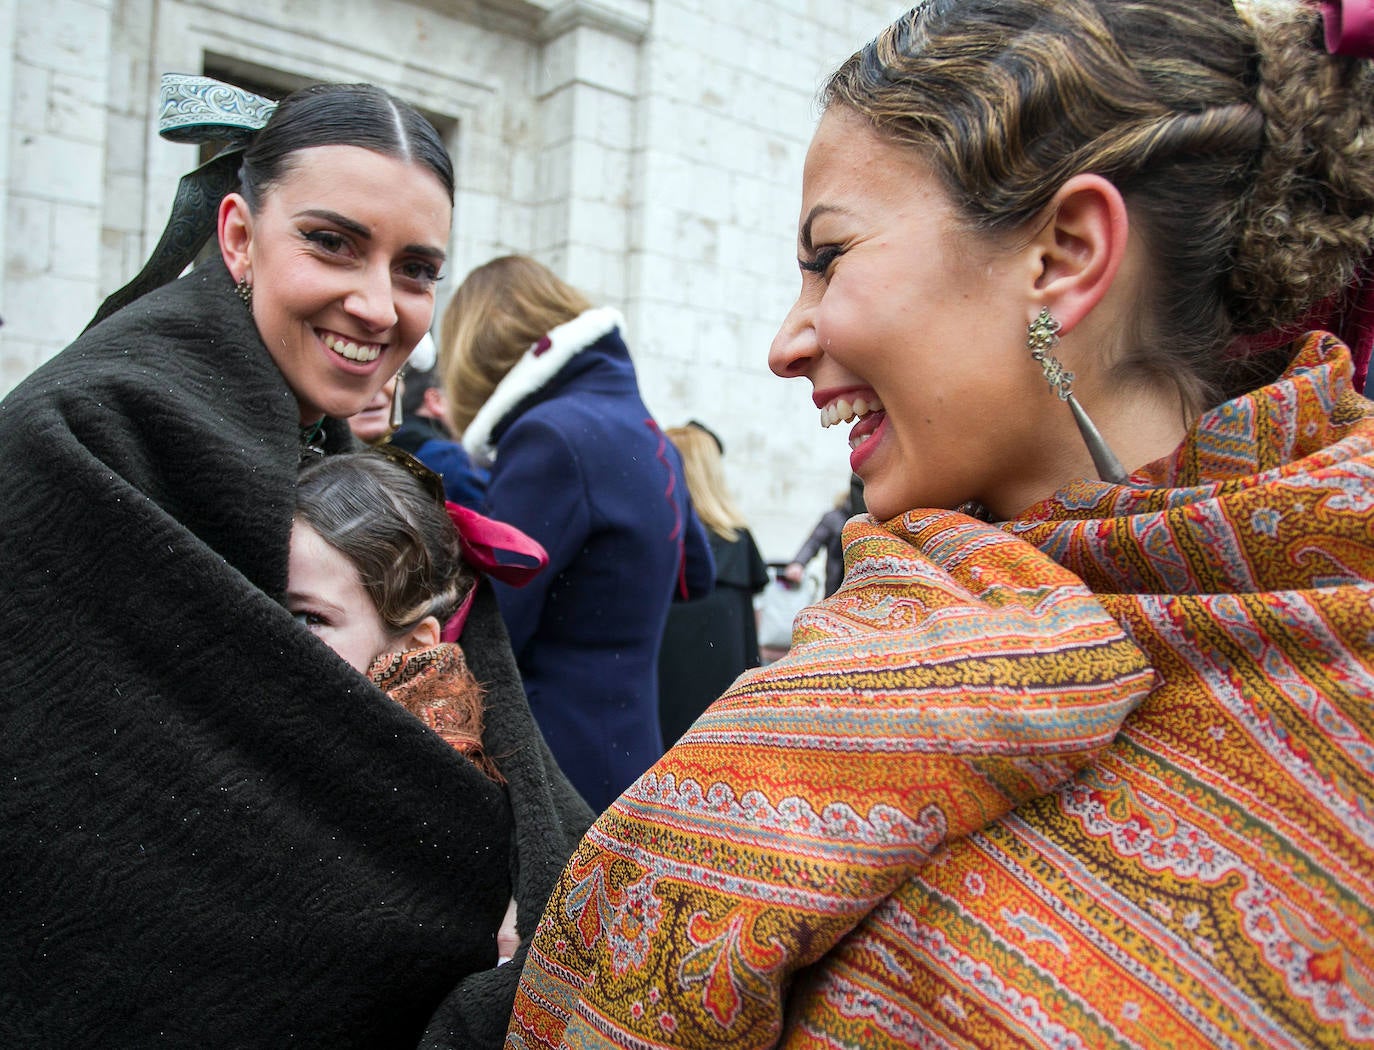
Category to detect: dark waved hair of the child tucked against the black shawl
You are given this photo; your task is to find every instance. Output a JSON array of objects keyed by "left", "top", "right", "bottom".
[{"left": 295, "top": 451, "right": 475, "bottom": 634}]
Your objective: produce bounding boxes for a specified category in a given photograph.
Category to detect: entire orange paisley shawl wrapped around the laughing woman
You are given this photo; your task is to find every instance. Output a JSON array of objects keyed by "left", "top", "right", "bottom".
[{"left": 507, "top": 334, "right": 1374, "bottom": 1050}]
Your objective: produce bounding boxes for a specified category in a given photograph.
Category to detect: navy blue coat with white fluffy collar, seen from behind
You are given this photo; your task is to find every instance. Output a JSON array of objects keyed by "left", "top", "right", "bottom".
[{"left": 464, "top": 311, "right": 714, "bottom": 811}]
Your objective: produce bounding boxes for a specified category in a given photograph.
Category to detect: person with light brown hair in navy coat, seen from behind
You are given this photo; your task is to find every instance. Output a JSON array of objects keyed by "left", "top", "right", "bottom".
[{"left": 441, "top": 256, "right": 714, "bottom": 811}]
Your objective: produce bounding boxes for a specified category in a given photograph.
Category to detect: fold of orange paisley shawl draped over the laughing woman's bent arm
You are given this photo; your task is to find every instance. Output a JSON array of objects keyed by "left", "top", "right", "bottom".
[{"left": 513, "top": 486, "right": 1154, "bottom": 1046}]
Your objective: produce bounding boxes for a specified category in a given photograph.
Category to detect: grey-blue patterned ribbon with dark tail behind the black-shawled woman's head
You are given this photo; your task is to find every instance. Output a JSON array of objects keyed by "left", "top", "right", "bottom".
[{"left": 87, "top": 73, "right": 276, "bottom": 327}]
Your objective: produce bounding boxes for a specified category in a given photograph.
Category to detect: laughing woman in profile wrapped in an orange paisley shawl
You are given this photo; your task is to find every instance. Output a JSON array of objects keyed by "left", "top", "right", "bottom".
[{"left": 507, "top": 0, "right": 1374, "bottom": 1050}]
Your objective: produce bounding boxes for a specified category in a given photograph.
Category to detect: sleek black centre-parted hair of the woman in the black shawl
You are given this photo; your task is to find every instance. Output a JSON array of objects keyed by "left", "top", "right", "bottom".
[{"left": 239, "top": 84, "right": 453, "bottom": 212}]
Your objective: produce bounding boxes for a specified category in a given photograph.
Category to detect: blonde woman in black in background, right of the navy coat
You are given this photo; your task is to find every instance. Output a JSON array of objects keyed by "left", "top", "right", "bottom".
[{"left": 658, "top": 419, "right": 768, "bottom": 748}]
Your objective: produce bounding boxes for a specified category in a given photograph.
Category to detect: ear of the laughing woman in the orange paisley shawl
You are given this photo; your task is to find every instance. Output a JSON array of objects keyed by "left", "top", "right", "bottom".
[{"left": 1033, "top": 175, "right": 1131, "bottom": 333}]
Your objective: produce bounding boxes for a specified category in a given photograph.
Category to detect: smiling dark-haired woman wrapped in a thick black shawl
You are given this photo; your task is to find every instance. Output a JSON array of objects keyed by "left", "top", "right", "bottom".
[{"left": 0, "top": 75, "right": 589, "bottom": 1047}]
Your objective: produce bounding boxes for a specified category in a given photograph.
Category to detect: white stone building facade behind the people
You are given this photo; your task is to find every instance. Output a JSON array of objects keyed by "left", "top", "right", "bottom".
[{"left": 0, "top": 0, "right": 907, "bottom": 561}]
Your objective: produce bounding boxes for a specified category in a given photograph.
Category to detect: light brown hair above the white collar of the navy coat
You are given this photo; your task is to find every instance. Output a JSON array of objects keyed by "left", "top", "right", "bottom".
[{"left": 438, "top": 256, "right": 592, "bottom": 434}]
